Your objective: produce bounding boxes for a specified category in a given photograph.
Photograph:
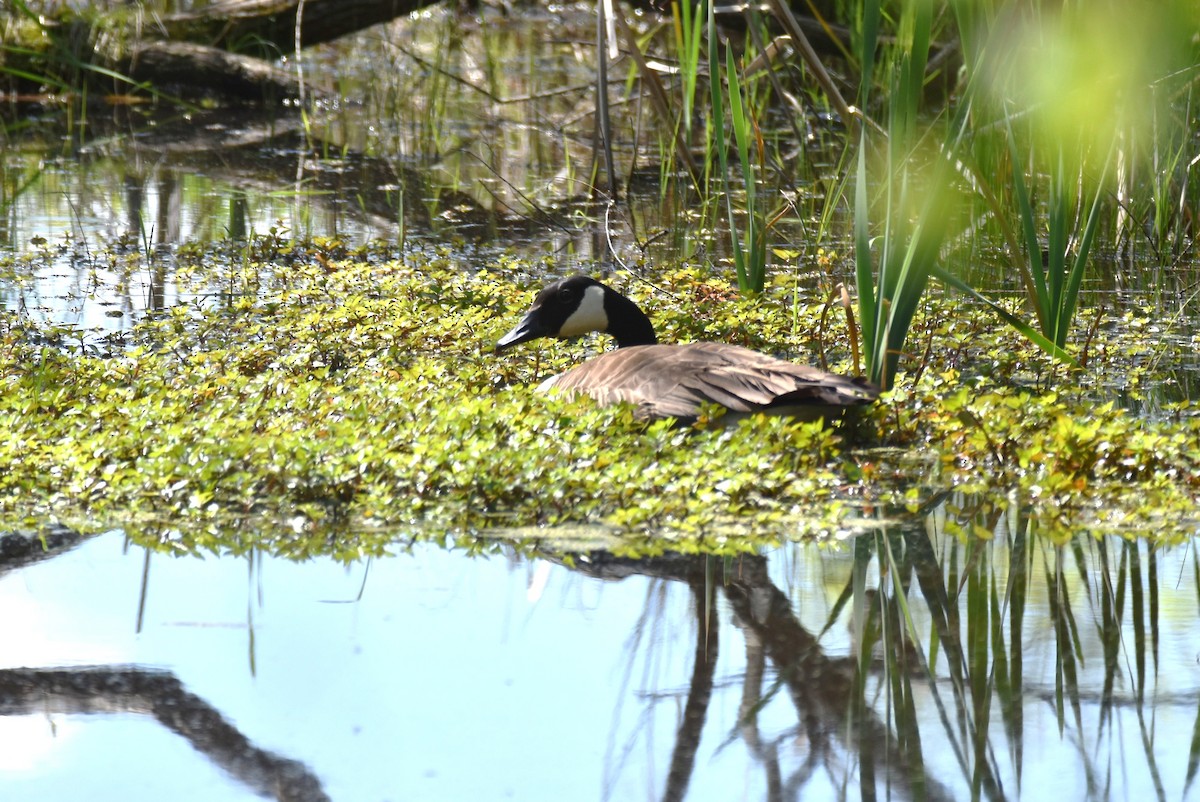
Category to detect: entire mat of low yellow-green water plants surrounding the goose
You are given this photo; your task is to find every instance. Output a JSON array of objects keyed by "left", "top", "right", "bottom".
[{"left": 0, "top": 247, "right": 1200, "bottom": 558}]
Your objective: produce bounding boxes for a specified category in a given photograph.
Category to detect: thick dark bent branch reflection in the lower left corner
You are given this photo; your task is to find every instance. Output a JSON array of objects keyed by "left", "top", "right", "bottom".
[{"left": 0, "top": 666, "right": 329, "bottom": 802}]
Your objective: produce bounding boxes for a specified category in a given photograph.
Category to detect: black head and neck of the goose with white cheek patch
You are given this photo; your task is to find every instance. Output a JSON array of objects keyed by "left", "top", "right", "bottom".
[{"left": 496, "top": 275, "right": 658, "bottom": 351}]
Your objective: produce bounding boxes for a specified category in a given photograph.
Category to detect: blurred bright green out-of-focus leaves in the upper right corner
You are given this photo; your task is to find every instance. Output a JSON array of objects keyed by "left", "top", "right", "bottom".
[{"left": 950, "top": 2, "right": 1198, "bottom": 359}]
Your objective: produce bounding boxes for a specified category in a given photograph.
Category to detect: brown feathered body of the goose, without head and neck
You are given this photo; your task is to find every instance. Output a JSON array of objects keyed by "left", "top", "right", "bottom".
[{"left": 546, "top": 342, "right": 878, "bottom": 418}]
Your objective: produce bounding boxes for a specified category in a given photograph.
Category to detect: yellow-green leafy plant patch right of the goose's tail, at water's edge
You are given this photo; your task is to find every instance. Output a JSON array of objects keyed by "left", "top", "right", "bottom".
[{"left": 890, "top": 373, "right": 1200, "bottom": 539}]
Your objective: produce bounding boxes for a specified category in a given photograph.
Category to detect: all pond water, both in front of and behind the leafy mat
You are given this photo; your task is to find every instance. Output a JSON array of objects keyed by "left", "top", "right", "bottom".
[{"left": 0, "top": 3, "right": 1200, "bottom": 802}]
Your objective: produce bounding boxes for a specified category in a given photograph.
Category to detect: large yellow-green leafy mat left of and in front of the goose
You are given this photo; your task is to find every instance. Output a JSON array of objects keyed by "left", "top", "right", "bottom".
[{"left": 0, "top": 253, "right": 864, "bottom": 552}]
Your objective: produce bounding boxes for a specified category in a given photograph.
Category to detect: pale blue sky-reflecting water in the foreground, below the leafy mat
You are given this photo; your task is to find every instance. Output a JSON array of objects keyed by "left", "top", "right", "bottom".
[{"left": 0, "top": 532, "right": 1200, "bottom": 801}]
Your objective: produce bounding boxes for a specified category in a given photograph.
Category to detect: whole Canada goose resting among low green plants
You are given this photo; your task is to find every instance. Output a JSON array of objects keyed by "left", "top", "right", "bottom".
[{"left": 496, "top": 275, "right": 878, "bottom": 420}]
